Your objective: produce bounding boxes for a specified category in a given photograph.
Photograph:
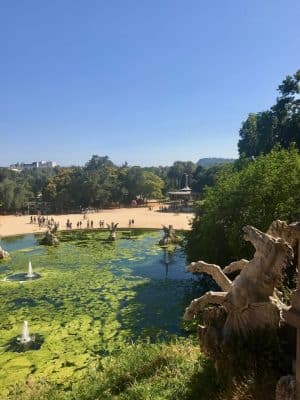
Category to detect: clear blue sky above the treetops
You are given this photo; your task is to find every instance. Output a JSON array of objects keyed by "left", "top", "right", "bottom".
[{"left": 0, "top": 0, "right": 300, "bottom": 165}]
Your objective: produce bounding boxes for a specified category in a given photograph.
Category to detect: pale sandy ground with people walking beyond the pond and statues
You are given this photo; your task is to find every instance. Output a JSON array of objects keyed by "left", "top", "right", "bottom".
[{"left": 0, "top": 208, "right": 194, "bottom": 237}]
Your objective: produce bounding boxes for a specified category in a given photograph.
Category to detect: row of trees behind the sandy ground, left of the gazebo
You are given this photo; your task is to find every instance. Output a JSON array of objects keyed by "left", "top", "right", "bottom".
[{"left": 0, "top": 155, "right": 165, "bottom": 212}]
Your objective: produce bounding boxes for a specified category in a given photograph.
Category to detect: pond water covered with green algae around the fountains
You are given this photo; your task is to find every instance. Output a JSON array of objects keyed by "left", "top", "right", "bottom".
[{"left": 0, "top": 231, "right": 204, "bottom": 390}]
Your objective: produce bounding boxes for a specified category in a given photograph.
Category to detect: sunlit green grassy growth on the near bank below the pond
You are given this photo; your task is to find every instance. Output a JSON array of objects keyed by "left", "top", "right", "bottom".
[{"left": 5, "top": 340, "right": 220, "bottom": 400}]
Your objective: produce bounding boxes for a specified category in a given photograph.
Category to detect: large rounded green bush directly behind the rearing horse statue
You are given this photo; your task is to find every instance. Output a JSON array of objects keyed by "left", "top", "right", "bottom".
[{"left": 186, "top": 149, "right": 300, "bottom": 265}]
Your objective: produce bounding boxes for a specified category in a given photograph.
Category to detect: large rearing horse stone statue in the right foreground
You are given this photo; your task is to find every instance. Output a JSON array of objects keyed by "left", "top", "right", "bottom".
[{"left": 184, "top": 223, "right": 293, "bottom": 340}]
